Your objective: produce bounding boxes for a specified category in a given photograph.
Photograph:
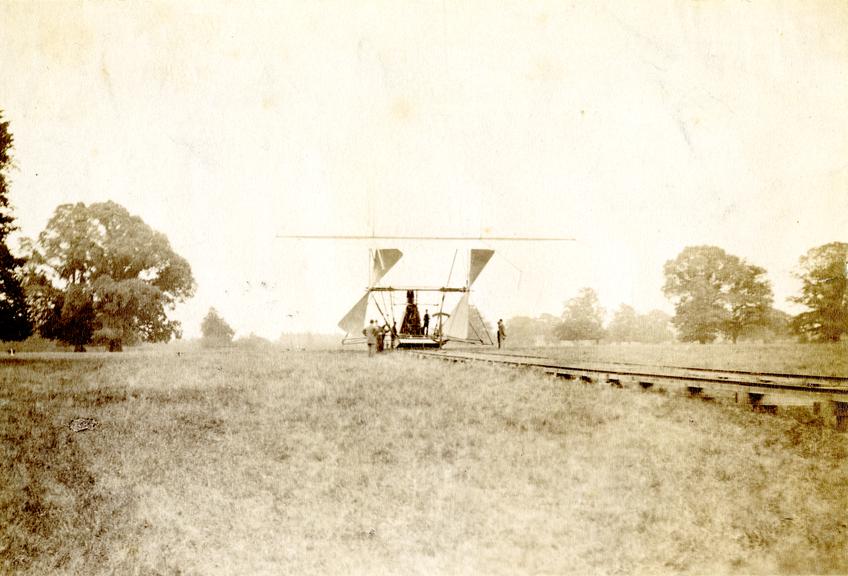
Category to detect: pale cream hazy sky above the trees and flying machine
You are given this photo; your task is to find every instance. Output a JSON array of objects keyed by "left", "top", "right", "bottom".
[{"left": 0, "top": 0, "right": 848, "bottom": 338}]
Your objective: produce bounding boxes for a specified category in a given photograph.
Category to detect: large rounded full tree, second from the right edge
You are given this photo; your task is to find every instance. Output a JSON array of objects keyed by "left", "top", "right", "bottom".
[{"left": 663, "top": 246, "right": 772, "bottom": 343}]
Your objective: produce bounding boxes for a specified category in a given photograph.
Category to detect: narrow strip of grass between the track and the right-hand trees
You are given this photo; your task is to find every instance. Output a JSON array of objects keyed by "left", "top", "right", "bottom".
[{"left": 504, "top": 341, "right": 848, "bottom": 377}]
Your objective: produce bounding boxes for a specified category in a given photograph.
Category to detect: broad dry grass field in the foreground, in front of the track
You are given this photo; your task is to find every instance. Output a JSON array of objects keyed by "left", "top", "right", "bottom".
[{"left": 0, "top": 350, "right": 848, "bottom": 575}]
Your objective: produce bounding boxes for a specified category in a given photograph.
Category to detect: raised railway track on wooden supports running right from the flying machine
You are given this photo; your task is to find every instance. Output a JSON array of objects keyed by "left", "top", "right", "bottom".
[{"left": 417, "top": 350, "right": 848, "bottom": 430}]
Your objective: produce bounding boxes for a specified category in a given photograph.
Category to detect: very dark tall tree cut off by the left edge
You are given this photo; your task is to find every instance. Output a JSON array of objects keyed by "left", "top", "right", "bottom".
[{"left": 0, "top": 110, "right": 32, "bottom": 341}]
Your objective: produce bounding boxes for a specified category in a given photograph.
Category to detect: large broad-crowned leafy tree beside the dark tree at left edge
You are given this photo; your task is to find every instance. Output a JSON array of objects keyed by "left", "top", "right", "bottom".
[{"left": 27, "top": 202, "right": 194, "bottom": 351}]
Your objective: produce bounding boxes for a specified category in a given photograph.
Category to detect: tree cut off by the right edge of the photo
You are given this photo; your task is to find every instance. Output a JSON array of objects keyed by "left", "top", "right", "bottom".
[{"left": 792, "top": 242, "right": 848, "bottom": 342}]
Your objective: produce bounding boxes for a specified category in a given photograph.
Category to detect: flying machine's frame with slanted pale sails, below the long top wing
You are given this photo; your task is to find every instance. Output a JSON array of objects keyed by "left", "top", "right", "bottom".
[{"left": 338, "top": 248, "right": 495, "bottom": 348}]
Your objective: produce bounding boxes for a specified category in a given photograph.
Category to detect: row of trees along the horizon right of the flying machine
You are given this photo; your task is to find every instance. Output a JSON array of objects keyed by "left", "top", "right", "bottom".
[{"left": 507, "top": 242, "right": 848, "bottom": 345}]
